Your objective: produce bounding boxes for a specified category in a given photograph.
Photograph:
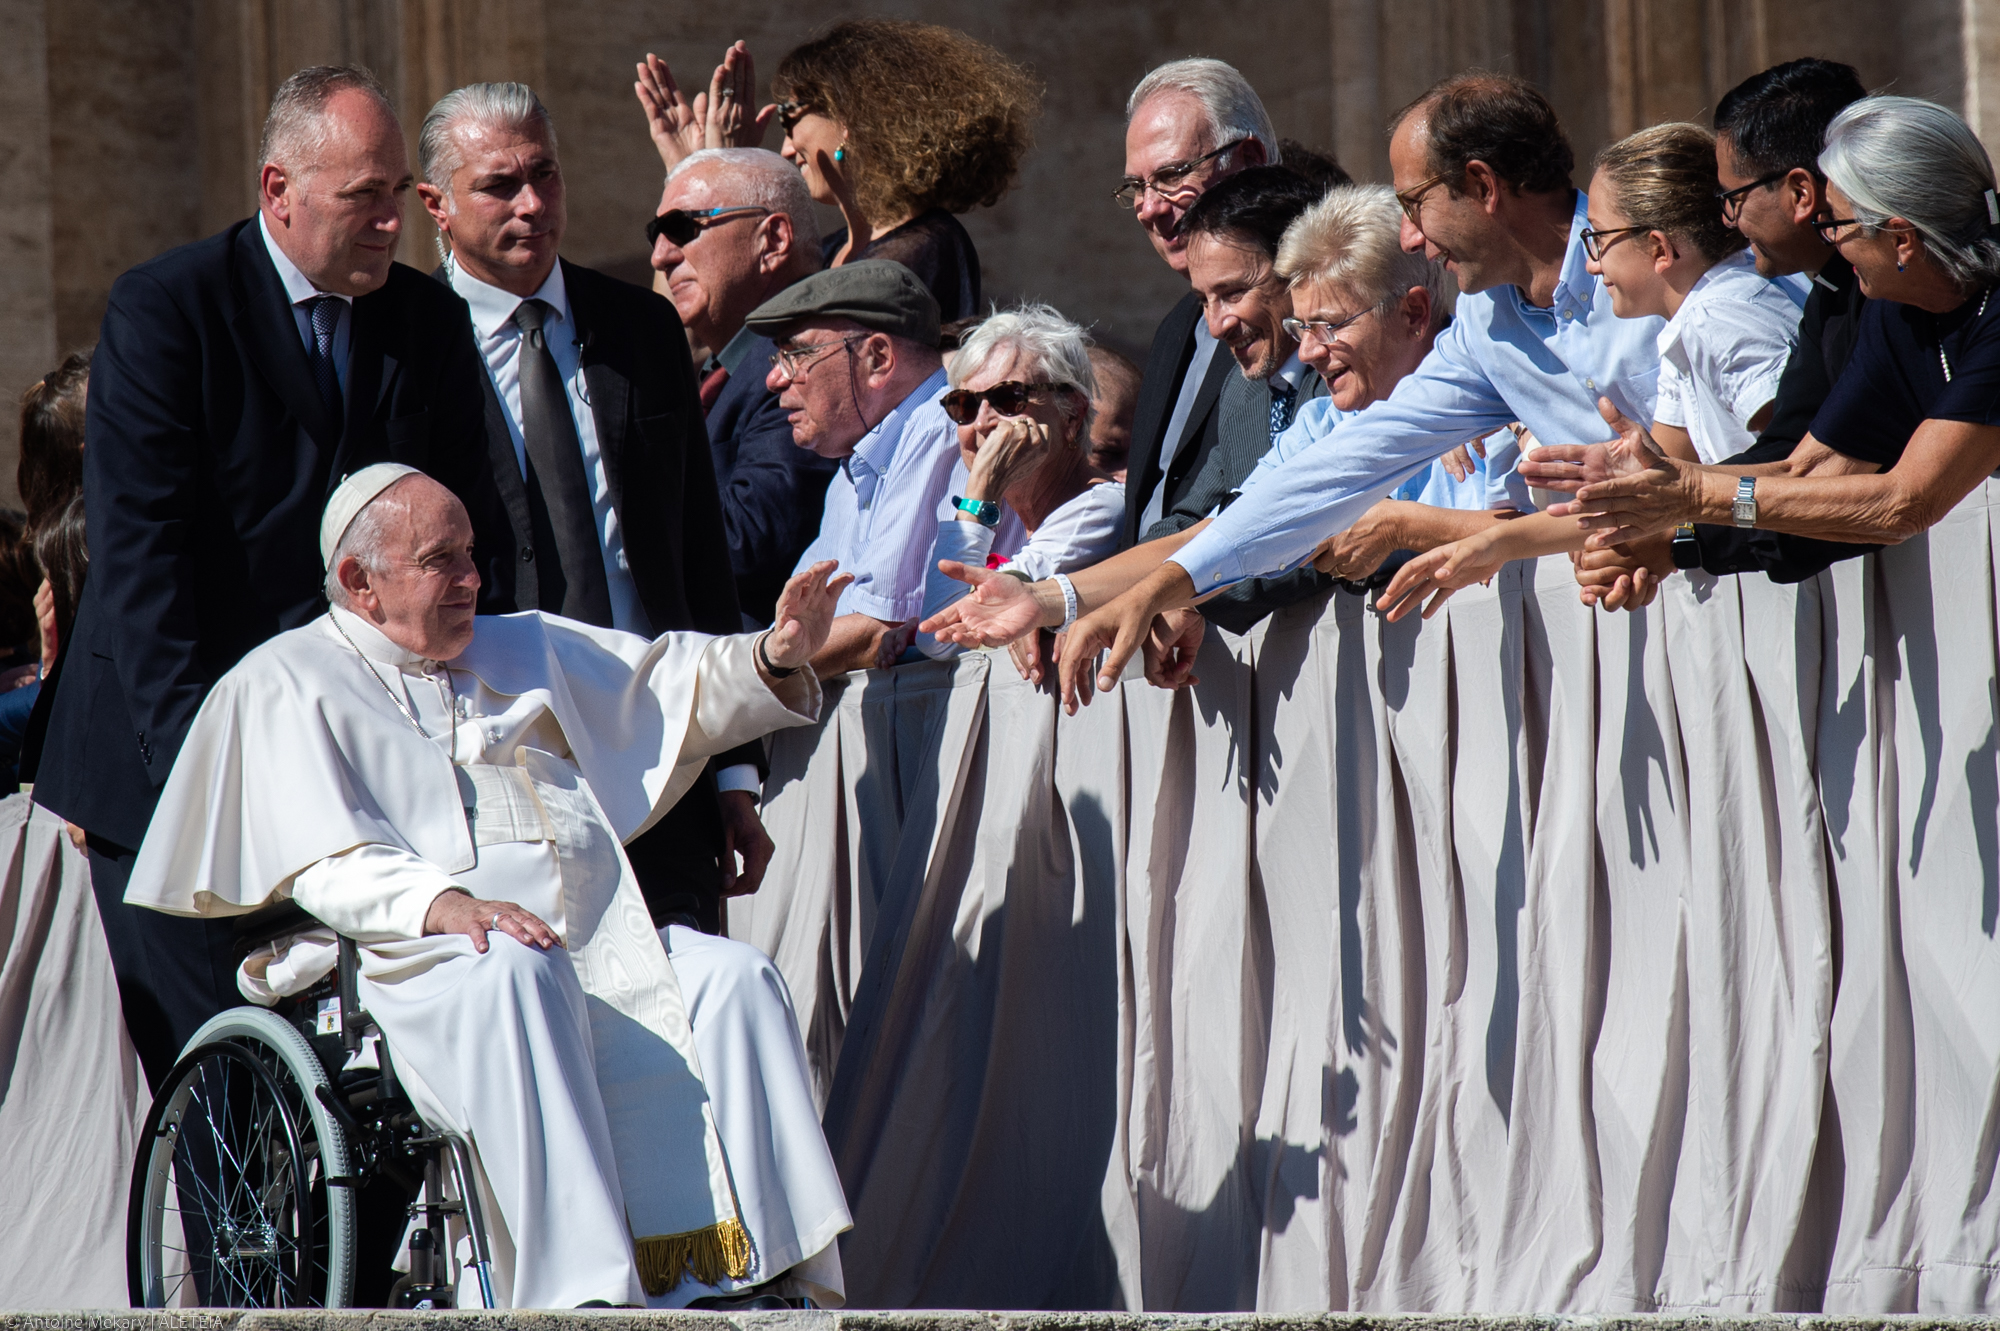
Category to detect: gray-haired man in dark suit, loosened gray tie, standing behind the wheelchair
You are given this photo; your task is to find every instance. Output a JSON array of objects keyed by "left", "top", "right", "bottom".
[{"left": 418, "top": 84, "right": 772, "bottom": 933}]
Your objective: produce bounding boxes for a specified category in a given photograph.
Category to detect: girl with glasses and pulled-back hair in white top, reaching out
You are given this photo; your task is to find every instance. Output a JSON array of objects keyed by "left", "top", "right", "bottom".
[{"left": 1382, "top": 124, "right": 1806, "bottom": 620}]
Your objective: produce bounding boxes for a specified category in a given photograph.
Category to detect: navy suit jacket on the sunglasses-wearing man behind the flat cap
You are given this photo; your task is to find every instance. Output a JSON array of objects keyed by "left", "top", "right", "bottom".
[{"left": 708, "top": 329, "right": 840, "bottom": 628}]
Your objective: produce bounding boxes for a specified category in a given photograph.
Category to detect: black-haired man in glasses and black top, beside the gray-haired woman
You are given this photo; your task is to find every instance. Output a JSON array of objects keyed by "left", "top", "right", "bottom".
[{"left": 1640, "top": 56, "right": 1876, "bottom": 582}]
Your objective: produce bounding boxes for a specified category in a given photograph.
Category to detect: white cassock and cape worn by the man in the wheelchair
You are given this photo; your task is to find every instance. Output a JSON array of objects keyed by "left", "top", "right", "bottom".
[{"left": 126, "top": 610, "right": 850, "bottom": 1307}]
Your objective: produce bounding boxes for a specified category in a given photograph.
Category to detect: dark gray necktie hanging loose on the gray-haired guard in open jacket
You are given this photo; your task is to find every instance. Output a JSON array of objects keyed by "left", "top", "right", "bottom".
[{"left": 514, "top": 300, "right": 612, "bottom": 628}]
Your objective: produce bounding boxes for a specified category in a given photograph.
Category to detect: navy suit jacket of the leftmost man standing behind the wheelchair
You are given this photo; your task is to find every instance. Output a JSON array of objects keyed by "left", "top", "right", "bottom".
[{"left": 34, "top": 218, "right": 494, "bottom": 847}]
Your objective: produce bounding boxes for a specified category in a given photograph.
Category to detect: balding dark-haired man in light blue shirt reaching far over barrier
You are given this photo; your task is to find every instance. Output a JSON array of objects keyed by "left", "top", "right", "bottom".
[{"left": 1070, "top": 74, "right": 1662, "bottom": 685}]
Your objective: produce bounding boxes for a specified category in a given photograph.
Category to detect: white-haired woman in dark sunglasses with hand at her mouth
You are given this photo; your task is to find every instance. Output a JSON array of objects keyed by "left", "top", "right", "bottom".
[{"left": 916, "top": 304, "right": 1124, "bottom": 656}]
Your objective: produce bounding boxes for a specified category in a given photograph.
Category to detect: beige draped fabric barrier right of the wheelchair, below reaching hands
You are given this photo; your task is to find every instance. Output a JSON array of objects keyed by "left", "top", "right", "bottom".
[{"left": 732, "top": 471, "right": 2000, "bottom": 1313}]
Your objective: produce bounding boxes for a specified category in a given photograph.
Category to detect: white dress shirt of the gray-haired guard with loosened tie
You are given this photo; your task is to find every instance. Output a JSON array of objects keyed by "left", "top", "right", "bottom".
[{"left": 450, "top": 264, "right": 652, "bottom": 638}]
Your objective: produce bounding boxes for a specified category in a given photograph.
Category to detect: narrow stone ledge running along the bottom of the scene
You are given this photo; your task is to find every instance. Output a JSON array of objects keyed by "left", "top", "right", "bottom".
[{"left": 0, "top": 1309, "right": 2000, "bottom": 1331}]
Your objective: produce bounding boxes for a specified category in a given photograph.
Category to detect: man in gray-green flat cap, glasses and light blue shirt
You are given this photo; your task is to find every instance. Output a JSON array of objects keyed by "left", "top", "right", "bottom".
[{"left": 746, "top": 260, "right": 958, "bottom": 677}]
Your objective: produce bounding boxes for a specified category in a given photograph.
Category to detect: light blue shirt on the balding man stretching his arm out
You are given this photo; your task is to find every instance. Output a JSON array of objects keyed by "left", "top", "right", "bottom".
[{"left": 1170, "top": 192, "right": 1664, "bottom": 592}]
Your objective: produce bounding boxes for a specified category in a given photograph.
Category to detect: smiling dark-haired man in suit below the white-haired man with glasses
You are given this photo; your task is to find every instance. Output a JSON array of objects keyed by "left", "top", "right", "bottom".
[{"left": 1142, "top": 166, "right": 1332, "bottom": 634}]
